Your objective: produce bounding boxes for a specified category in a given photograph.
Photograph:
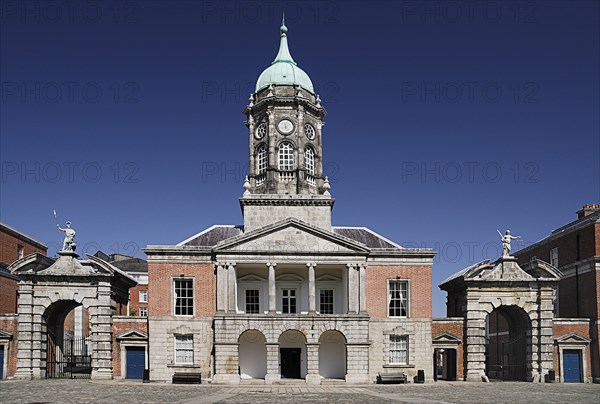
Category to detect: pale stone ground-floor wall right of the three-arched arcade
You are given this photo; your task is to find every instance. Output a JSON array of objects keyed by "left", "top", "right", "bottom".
[{"left": 369, "top": 318, "right": 433, "bottom": 382}]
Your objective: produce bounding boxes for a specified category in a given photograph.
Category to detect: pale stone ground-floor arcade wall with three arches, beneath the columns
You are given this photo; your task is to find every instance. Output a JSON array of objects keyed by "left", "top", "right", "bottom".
[{"left": 213, "top": 314, "right": 370, "bottom": 384}]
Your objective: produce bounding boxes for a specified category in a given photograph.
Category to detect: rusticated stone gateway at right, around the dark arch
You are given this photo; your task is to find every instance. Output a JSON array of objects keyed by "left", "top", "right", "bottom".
[{"left": 440, "top": 256, "right": 562, "bottom": 382}]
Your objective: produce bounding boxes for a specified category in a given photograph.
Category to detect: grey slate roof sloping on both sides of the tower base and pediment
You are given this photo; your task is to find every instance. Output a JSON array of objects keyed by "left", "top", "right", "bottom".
[{"left": 177, "top": 225, "right": 402, "bottom": 249}]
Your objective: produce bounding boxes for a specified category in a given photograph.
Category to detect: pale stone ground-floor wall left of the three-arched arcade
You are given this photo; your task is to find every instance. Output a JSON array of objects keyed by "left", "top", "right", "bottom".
[{"left": 148, "top": 317, "right": 213, "bottom": 382}]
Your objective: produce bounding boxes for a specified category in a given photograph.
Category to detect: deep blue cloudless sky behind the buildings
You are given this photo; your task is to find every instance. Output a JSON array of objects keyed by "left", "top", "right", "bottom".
[{"left": 0, "top": 1, "right": 600, "bottom": 316}]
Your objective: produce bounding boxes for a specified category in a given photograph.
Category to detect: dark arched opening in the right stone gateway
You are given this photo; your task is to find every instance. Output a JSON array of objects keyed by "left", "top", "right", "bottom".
[{"left": 485, "top": 306, "right": 531, "bottom": 381}]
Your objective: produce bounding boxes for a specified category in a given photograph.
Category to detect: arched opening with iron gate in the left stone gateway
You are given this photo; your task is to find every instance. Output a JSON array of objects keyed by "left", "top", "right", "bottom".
[{"left": 43, "top": 300, "right": 92, "bottom": 379}]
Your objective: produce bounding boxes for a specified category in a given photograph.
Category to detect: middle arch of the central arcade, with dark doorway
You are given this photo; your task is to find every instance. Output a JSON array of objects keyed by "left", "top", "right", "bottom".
[{"left": 279, "top": 330, "right": 307, "bottom": 379}]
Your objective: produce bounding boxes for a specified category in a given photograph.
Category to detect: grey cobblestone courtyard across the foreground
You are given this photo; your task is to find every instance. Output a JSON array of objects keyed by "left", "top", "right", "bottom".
[{"left": 0, "top": 380, "right": 600, "bottom": 404}]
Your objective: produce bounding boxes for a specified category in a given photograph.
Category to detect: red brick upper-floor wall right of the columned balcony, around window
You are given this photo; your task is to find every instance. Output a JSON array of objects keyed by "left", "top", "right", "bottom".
[{"left": 367, "top": 265, "right": 432, "bottom": 318}]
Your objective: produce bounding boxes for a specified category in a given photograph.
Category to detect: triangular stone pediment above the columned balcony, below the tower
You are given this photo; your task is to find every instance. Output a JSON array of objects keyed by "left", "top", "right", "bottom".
[{"left": 214, "top": 218, "right": 369, "bottom": 254}]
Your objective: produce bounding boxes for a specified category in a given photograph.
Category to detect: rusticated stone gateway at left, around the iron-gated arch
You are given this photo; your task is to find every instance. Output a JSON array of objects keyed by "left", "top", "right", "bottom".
[{"left": 8, "top": 251, "right": 137, "bottom": 379}]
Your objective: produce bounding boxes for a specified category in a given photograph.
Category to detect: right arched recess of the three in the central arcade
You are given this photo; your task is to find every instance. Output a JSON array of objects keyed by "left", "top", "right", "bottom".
[{"left": 319, "top": 330, "right": 346, "bottom": 379}]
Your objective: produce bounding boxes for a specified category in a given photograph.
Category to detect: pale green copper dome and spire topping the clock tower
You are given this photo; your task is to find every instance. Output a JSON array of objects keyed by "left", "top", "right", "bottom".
[{"left": 256, "top": 23, "right": 315, "bottom": 94}]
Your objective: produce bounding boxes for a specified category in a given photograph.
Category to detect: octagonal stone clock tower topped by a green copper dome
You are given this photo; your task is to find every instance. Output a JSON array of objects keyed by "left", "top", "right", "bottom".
[{"left": 240, "top": 22, "right": 333, "bottom": 230}]
